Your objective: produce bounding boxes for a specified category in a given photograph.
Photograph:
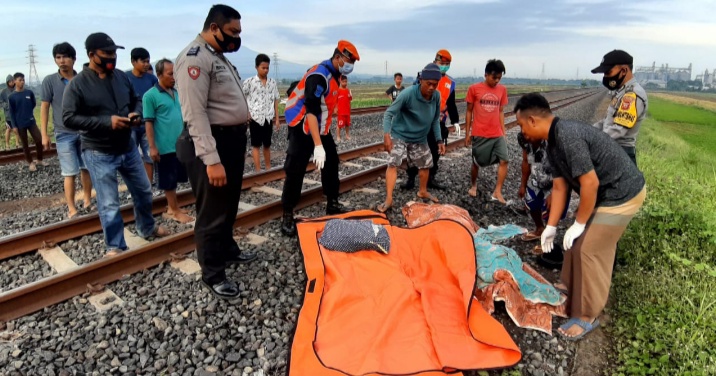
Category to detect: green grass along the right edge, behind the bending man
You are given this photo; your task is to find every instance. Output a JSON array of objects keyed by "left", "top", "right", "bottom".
[{"left": 609, "top": 101, "right": 716, "bottom": 375}]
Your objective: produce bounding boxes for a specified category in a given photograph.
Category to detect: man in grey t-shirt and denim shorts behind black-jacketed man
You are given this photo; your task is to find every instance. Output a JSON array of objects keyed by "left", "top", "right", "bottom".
[{"left": 40, "top": 42, "right": 92, "bottom": 218}]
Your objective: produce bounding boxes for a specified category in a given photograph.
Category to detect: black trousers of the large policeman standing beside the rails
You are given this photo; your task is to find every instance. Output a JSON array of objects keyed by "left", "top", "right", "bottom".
[{"left": 177, "top": 124, "right": 247, "bottom": 284}]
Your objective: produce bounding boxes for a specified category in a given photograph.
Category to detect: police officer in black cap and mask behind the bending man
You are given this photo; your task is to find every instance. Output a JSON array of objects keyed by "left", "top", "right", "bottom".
[{"left": 592, "top": 50, "right": 648, "bottom": 165}]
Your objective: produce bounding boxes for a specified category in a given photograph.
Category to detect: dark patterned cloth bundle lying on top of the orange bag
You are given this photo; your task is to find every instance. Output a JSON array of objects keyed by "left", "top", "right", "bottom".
[{"left": 318, "top": 219, "right": 390, "bottom": 254}]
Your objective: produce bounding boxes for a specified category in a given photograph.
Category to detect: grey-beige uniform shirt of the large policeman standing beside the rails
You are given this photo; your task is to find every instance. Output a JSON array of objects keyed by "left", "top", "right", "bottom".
[{"left": 174, "top": 35, "right": 250, "bottom": 166}]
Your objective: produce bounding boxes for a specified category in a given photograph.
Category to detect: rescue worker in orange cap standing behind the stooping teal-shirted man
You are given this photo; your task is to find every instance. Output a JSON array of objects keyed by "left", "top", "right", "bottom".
[{"left": 400, "top": 50, "right": 460, "bottom": 190}]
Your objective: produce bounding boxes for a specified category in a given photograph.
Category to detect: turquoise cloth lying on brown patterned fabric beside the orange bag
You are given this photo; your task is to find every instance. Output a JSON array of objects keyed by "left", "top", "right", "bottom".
[{"left": 473, "top": 224, "right": 564, "bottom": 306}]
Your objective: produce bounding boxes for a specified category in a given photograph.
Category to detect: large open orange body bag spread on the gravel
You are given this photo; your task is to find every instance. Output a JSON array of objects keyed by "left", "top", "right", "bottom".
[{"left": 289, "top": 211, "right": 521, "bottom": 376}]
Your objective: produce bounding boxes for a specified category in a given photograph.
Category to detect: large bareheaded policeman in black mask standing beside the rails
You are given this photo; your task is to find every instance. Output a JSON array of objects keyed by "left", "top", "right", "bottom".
[{"left": 174, "top": 5, "right": 256, "bottom": 299}]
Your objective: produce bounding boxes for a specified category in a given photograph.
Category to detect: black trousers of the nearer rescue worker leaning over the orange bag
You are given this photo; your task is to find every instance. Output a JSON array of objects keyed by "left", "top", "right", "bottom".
[{"left": 281, "top": 125, "right": 340, "bottom": 212}]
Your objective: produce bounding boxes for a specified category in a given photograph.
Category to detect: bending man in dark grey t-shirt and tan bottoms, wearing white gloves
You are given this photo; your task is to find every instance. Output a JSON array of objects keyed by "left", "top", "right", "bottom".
[{"left": 514, "top": 93, "right": 646, "bottom": 340}]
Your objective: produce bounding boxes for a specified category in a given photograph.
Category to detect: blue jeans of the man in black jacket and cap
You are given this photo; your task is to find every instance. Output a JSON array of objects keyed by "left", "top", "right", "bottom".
[{"left": 82, "top": 148, "right": 154, "bottom": 250}]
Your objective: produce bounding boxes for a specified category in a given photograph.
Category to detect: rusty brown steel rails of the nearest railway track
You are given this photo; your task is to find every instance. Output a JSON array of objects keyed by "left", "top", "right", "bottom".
[{"left": 0, "top": 87, "right": 599, "bottom": 325}]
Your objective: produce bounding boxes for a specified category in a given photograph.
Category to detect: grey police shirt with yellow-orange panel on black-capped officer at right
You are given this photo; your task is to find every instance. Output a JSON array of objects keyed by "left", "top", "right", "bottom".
[{"left": 594, "top": 78, "right": 648, "bottom": 147}]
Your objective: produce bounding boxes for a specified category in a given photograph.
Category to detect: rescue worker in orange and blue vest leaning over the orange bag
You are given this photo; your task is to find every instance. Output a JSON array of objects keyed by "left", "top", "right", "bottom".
[{"left": 281, "top": 40, "right": 360, "bottom": 236}]
